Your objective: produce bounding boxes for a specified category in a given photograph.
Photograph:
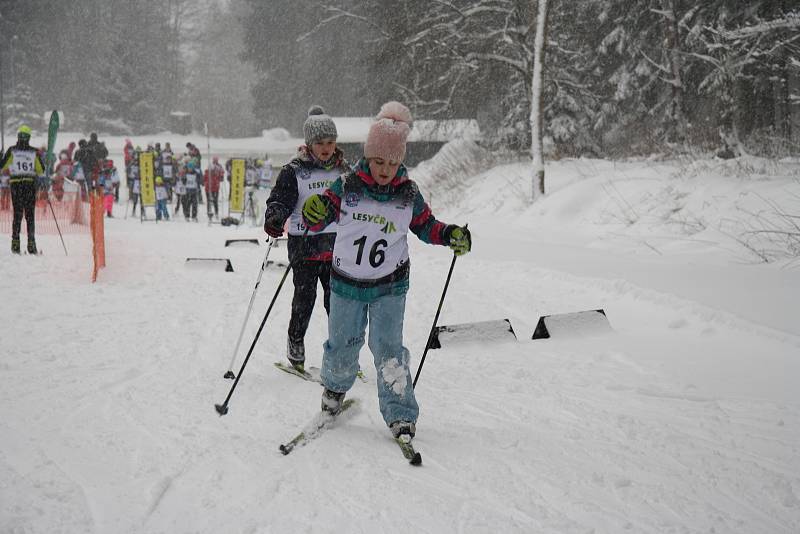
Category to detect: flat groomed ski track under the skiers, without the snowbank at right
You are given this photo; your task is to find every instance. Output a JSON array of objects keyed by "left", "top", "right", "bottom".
[{"left": 0, "top": 206, "right": 800, "bottom": 534}]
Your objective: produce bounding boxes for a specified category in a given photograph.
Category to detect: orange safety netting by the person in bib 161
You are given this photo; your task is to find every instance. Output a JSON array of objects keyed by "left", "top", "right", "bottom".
[{"left": 0, "top": 189, "right": 106, "bottom": 282}]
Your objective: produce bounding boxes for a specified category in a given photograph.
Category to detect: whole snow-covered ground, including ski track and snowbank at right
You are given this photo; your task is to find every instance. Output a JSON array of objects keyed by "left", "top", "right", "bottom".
[{"left": 0, "top": 139, "right": 800, "bottom": 534}]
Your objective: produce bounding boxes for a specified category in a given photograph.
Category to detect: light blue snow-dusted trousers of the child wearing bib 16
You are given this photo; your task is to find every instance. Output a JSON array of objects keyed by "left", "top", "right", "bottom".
[{"left": 322, "top": 292, "right": 419, "bottom": 425}]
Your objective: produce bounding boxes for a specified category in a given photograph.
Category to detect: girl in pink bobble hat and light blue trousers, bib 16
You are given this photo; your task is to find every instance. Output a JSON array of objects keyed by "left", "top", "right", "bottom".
[{"left": 303, "top": 102, "right": 472, "bottom": 440}]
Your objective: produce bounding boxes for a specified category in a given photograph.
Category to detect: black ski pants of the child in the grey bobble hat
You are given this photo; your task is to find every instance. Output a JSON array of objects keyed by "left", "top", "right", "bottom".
[{"left": 289, "top": 260, "right": 331, "bottom": 343}]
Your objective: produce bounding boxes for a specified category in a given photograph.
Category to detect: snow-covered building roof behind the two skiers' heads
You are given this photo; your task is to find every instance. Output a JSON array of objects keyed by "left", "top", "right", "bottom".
[{"left": 333, "top": 117, "right": 480, "bottom": 143}]
